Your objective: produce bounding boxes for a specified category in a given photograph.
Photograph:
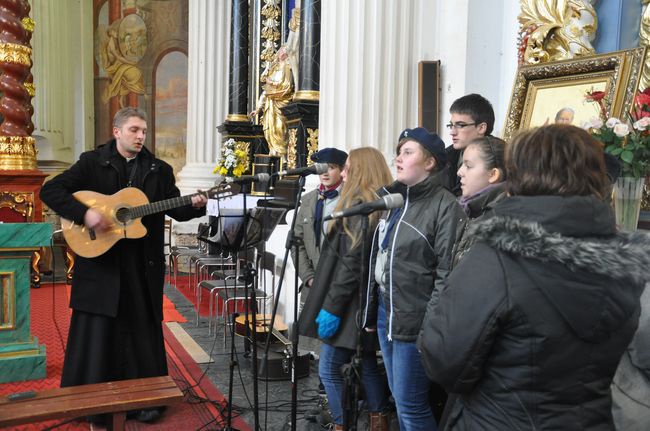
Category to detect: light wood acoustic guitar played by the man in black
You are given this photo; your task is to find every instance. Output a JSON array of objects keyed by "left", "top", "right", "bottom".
[{"left": 61, "top": 184, "right": 239, "bottom": 257}]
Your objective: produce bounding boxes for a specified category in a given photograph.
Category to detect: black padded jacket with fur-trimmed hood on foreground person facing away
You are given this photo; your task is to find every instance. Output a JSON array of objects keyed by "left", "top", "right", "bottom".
[{"left": 418, "top": 196, "right": 650, "bottom": 430}]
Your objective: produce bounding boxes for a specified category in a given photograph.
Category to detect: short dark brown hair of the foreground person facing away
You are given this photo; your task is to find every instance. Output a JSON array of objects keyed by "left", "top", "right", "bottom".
[{"left": 506, "top": 124, "right": 609, "bottom": 199}]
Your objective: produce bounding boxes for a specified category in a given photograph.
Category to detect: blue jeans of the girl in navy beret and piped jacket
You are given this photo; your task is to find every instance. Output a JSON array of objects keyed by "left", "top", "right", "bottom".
[{"left": 377, "top": 294, "right": 437, "bottom": 431}]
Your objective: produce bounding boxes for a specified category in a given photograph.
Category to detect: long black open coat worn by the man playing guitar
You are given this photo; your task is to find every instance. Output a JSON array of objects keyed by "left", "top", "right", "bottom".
[{"left": 41, "top": 139, "right": 205, "bottom": 320}]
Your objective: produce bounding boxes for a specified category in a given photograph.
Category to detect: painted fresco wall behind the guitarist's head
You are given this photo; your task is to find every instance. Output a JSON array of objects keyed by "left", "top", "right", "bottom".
[{"left": 94, "top": 0, "right": 189, "bottom": 164}]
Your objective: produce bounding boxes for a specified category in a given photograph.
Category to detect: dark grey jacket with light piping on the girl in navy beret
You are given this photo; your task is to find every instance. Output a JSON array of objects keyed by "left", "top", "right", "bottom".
[{"left": 364, "top": 176, "right": 465, "bottom": 342}]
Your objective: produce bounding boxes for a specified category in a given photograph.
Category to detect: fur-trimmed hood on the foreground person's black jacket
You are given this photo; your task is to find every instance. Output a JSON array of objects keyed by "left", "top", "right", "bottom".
[{"left": 468, "top": 196, "right": 650, "bottom": 342}]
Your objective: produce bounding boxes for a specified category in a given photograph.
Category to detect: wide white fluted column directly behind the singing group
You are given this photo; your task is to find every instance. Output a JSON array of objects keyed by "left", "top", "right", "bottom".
[{"left": 319, "top": 0, "right": 427, "bottom": 164}]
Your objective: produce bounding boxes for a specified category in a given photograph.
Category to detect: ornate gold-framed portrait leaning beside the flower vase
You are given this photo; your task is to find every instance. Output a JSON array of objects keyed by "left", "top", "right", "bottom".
[{"left": 503, "top": 47, "right": 645, "bottom": 141}]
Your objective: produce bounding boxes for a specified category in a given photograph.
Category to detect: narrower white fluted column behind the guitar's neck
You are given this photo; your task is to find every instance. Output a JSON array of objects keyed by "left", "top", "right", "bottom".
[{"left": 178, "top": 0, "right": 231, "bottom": 199}]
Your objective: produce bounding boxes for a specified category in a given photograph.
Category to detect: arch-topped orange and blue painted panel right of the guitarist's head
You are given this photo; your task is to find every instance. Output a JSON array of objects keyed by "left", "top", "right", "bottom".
[{"left": 154, "top": 51, "right": 187, "bottom": 174}]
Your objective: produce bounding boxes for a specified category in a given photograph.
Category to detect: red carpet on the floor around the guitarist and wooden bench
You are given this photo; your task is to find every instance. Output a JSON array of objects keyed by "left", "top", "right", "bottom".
[{"left": 0, "top": 284, "right": 250, "bottom": 431}]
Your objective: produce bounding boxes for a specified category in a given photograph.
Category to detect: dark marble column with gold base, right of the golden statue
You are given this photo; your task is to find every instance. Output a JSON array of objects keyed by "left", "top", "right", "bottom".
[{"left": 294, "top": 0, "right": 321, "bottom": 101}]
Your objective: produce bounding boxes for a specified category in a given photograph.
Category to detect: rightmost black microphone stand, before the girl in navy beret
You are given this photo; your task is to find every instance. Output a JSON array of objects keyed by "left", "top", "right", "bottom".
[{"left": 343, "top": 214, "right": 369, "bottom": 431}]
